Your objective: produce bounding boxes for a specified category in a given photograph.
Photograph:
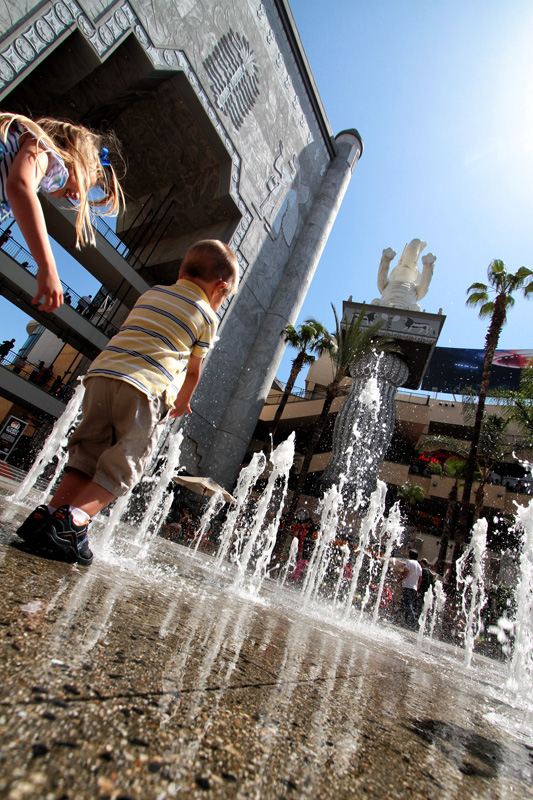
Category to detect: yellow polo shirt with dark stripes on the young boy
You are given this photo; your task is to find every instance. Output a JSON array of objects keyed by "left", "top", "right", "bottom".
[{"left": 85, "top": 280, "right": 218, "bottom": 405}]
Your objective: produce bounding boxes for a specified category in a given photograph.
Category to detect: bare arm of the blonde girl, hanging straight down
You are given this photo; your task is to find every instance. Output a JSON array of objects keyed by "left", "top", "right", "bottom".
[{"left": 6, "top": 137, "right": 63, "bottom": 311}]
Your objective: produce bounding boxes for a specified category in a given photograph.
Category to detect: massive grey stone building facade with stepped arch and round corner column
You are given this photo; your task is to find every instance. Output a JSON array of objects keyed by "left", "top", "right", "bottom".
[{"left": 0, "top": 0, "right": 362, "bottom": 486}]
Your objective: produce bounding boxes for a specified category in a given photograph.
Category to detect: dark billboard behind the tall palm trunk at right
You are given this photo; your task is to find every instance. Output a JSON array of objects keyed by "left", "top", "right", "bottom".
[{"left": 421, "top": 347, "right": 533, "bottom": 394}]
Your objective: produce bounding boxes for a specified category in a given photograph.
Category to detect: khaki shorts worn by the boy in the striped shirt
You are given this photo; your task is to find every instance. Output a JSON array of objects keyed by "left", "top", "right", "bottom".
[{"left": 65, "top": 376, "right": 170, "bottom": 497}]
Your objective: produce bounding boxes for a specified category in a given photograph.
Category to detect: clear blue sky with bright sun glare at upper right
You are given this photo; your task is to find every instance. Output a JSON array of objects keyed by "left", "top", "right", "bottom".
[{"left": 0, "top": 0, "right": 533, "bottom": 383}]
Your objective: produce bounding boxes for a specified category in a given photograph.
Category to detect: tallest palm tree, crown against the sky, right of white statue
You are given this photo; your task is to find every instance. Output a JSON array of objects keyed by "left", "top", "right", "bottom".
[{"left": 450, "top": 259, "right": 533, "bottom": 591}]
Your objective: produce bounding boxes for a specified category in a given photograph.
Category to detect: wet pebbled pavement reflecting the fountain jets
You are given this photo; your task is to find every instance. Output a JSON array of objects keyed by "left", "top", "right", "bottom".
[{"left": 0, "top": 498, "right": 533, "bottom": 800}]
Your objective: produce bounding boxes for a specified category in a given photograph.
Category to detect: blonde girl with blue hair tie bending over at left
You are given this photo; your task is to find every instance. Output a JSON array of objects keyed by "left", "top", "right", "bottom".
[{"left": 0, "top": 113, "right": 124, "bottom": 311}]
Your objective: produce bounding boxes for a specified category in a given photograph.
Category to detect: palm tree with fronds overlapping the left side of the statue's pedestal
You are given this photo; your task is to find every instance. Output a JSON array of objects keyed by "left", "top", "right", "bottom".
[{"left": 287, "top": 304, "right": 398, "bottom": 519}]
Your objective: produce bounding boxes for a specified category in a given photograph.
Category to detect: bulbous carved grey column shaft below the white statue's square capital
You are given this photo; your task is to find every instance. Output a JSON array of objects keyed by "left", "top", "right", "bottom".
[{"left": 322, "top": 353, "right": 409, "bottom": 501}]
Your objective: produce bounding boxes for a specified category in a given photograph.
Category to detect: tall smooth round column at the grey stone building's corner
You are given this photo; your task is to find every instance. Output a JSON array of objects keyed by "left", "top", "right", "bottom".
[{"left": 199, "top": 131, "right": 363, "bottom": 488}]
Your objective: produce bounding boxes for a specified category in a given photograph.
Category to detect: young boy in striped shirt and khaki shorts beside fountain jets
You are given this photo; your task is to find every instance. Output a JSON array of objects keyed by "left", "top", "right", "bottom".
[{"left": 17, "top": 239, "right": 239, "bottom": 566}]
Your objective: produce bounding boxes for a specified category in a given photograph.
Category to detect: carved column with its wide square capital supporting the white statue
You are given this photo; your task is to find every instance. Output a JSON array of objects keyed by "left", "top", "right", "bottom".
[{"left": 322, "top": 302, "right": 446, "bottom": 505}]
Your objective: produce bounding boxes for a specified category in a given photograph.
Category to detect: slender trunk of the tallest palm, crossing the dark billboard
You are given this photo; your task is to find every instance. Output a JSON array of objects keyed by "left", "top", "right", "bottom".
[{"left": 449, "top": 292, "right": 505, "bottom": 594}]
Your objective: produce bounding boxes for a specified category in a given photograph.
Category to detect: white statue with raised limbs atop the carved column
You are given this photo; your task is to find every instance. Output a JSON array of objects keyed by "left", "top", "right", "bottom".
[{"left": 372, "top": 239, "right": 437, "bottom": 311}]
